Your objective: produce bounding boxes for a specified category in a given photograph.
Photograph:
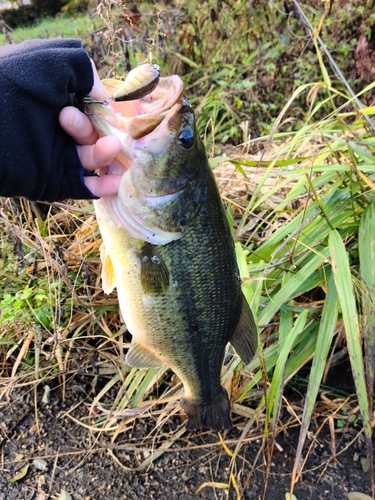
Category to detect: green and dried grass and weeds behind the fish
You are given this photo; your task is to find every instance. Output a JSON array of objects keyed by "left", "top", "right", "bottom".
[{"left": 0, "top": 0, "right": 375, "bottom": 495}]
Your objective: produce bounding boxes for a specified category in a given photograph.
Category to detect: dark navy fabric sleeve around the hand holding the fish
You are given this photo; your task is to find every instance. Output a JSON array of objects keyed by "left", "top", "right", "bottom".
[{"left": 0, "top": 39, "right": 94, "bottom": 202}]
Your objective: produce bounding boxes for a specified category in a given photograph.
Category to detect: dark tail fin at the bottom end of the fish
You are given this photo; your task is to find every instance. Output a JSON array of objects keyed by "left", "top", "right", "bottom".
[{"left": 180, "top": 388, "right": 232, "bottom": 431}]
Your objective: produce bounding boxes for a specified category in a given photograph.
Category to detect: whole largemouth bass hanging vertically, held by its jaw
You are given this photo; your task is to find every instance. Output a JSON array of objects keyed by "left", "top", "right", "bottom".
[{"left": 86, "top": 65, "right": 257, "bottom": 431}]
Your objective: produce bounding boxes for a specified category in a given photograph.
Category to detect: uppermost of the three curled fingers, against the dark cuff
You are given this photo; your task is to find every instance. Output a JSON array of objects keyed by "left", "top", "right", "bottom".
[{"left": 59, "top": 106, "right": 98, "bottom": 144}]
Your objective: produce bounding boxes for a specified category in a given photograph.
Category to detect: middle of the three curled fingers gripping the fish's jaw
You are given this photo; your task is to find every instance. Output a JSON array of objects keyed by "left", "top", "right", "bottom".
[{"left": 78, "top": 135, "right": 121, "bottom": 170}]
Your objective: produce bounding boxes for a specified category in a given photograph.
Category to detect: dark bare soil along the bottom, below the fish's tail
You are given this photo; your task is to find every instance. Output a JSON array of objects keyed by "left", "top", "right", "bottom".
[{"left": 0, "top": 378, "right": 371, "bottom": 500}]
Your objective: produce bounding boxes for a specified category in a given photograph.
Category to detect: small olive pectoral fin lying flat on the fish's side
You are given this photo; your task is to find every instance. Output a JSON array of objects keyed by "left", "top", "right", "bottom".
[{"left": 139, "top": 243, "right": 169, "bottom": 295}]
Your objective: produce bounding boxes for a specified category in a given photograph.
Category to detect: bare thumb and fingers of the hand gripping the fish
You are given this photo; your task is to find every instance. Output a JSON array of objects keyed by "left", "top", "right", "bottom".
[{"left": 59, "top": 61, "right": 121, "bottom": 197}]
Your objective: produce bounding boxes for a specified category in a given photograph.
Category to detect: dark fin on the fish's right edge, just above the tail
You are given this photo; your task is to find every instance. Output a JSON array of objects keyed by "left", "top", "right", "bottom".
[{"left": 230, "top": 295, "right": 257, "bottom": 364}]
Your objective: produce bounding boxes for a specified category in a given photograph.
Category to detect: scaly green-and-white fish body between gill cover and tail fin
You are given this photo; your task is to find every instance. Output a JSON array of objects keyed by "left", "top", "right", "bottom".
[{"left": 96, "top": 163, "right": 241, "bottom": 425}]
